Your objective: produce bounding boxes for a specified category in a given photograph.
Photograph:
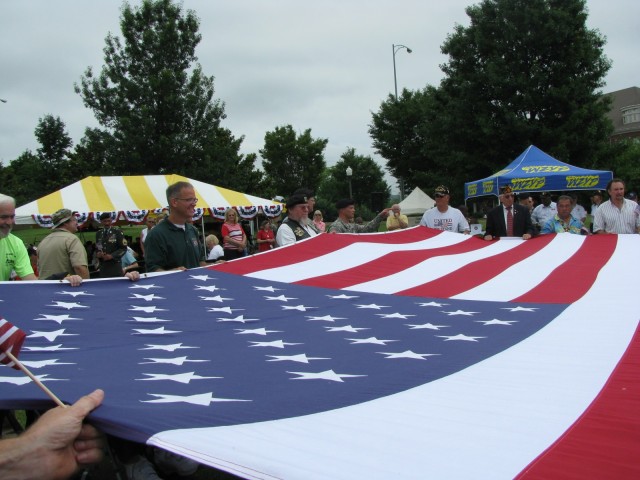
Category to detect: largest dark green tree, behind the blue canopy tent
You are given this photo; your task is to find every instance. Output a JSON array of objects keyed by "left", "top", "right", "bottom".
[{"left": 370, "top": 0, "right": 613, "bottom": 197}]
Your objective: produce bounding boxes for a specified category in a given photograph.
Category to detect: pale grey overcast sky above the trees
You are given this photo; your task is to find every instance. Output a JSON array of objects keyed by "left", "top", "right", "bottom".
[{"left": 0, "top": 0, "right": 640, "bottom": 191}]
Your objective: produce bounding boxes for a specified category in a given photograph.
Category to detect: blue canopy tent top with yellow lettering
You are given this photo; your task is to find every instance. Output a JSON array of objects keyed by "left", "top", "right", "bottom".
[{"left": 464, "top": 145, "right": 613, "bottom": 201}]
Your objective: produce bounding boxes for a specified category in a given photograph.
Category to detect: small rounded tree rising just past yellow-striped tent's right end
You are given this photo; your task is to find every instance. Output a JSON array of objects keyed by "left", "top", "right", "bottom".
[{"left": 260, "top": 125, "right": 328, "bottom": 198}]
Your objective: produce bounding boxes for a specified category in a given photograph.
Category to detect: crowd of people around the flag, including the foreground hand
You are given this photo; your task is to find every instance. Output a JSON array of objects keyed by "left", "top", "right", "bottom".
[{"left": 0, "top": 178, "right": 640, "bottom": 480}]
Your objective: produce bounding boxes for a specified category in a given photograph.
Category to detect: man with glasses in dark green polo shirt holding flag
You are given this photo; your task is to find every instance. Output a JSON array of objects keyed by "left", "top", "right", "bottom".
[{"left": 144, "top": 182, "right": 207, "bottom": 272}]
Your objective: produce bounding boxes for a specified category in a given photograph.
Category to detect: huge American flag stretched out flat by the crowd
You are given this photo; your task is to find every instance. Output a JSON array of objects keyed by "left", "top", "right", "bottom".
[{"left": 0, "top": 227, "right": 640, "bottom": 479}]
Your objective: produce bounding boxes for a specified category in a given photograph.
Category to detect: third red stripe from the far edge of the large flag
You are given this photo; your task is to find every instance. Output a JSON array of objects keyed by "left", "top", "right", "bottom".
[{"left": 398, "top": 235, "right": 553, "bottom": 298}]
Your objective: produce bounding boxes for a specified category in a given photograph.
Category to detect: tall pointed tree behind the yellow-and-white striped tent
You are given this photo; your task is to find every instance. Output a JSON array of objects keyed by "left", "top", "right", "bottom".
[{"left": 75, "top": 0, "right": 256, "bottom": 188}]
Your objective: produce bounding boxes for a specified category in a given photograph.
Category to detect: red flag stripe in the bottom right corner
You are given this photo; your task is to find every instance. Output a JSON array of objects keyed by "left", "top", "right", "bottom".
[{"left": 516, "top": 322, "right": 640, "bottom": 480}]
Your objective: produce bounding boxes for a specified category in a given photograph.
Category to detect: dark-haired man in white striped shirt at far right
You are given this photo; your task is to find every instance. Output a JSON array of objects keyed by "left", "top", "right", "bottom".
[{"left": 593, "top": 178, "right": 640, "bottom": 233}]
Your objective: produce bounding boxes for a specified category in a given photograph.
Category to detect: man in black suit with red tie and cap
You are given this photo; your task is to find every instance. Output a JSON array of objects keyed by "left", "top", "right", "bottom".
[{"left": 484, "top": 185, "right": 533, "bottom": 240}]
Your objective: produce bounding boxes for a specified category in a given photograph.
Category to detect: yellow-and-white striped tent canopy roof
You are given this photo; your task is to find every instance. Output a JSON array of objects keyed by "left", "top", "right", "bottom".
[{"left": 16, "top": 175, "right": 280, "bottom": 224}]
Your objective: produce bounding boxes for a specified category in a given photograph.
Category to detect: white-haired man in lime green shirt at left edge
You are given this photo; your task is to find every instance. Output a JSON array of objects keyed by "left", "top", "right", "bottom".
[{"left": 0, "top": 193, "right": 37, "bottom": 281}]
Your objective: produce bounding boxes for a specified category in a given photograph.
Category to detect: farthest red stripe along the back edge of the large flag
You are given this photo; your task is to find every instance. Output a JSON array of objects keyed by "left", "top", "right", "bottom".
[{"left": 210, "top": 228, "right": 442, "bottom": 275}]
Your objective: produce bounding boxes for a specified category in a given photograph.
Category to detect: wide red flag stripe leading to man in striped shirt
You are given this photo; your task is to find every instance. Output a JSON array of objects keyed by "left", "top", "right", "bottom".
[{"left": 513, "top": 234, "right": 618, "bottom": 303}]
